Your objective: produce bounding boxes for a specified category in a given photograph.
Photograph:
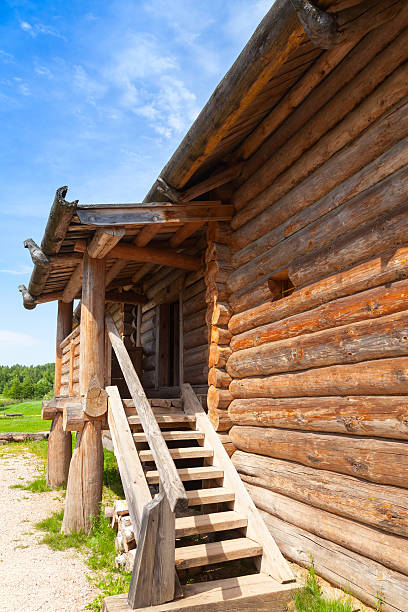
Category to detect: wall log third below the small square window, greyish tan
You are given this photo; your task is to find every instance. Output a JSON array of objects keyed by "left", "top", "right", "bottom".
[{"left": 226, "top": 310, "right": 408, "bottom": 378}]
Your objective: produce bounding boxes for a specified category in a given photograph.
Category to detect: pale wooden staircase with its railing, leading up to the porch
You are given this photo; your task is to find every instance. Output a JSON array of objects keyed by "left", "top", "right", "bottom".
[{"left": 104, "top": 318, "right": 297, "bottom": 612}]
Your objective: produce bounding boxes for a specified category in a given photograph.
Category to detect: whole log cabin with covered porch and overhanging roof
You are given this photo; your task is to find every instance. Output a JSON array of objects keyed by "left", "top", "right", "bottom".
[{"left": 20, "top": 0, "right": 408, "bottom": 612}]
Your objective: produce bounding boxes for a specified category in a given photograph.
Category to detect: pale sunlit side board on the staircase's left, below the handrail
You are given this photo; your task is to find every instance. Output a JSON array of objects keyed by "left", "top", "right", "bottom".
[{"left": 106, "top": 387, "right": 152, "bottom": 533}]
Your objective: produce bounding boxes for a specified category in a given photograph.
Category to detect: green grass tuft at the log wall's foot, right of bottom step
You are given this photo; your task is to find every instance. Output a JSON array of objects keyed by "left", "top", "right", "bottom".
[{"left": 293, "top": 565, "right": 363, "bottom": 612}]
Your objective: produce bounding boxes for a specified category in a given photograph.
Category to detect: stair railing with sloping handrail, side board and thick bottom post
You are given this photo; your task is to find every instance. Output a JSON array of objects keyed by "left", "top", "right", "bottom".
[{"left": 105, "top": 313, "right": 187, "bottom": 608}]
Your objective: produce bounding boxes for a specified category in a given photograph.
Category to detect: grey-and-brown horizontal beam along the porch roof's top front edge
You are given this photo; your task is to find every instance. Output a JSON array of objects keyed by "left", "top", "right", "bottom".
[{"left": 77, "top": 200, "right": 230, "bottom": 227}]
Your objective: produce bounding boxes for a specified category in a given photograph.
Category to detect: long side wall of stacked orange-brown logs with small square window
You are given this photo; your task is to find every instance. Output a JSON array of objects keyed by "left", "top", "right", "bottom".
[{"left": 223, "top": 7, "right": 408, "bottom": 610}]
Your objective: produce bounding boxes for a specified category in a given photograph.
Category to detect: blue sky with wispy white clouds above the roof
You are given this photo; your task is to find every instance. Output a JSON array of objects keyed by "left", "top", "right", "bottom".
[{"left": 0, "top": 0, "right": 272, "bottom": 365}]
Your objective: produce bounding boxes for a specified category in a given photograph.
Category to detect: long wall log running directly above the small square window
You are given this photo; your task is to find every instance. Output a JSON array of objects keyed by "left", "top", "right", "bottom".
[{"left": 228, "top": 164, "right": 408, "bottom": 291}]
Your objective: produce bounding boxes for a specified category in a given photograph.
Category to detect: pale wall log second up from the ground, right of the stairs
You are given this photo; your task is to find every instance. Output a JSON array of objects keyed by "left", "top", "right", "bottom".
[{"left": 246, "top": 483, "right": 408, "bottom": 575}]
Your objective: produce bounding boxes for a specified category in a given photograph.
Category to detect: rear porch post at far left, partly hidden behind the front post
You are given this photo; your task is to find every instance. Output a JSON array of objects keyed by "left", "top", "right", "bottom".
[{"left": 47, "top": 301, "right": 73, "bottom": 489}]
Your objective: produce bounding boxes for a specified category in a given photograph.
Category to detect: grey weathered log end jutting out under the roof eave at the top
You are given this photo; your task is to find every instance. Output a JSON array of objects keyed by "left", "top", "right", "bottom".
[{"left": 291, "top": 0, "right": 342, "bottom": 49}]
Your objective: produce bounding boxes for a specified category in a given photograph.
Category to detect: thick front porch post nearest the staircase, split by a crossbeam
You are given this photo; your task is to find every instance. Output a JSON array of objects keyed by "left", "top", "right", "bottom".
[{"left": 62, "top": 253, "right": 105, "bottom": 533}]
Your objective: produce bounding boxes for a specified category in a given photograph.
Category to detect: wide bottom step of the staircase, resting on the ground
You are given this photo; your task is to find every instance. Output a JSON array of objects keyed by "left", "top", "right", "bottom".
[{"left": 103, "top": 574, "right": 299, "bottom": 612}]
